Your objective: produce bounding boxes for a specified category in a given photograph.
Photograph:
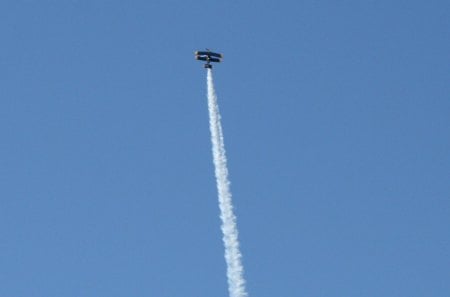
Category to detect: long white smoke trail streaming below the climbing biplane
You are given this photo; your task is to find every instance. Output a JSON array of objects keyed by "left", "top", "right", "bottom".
[{"left": 207, "top": 69, "right": 247, "bottom": 297}]
